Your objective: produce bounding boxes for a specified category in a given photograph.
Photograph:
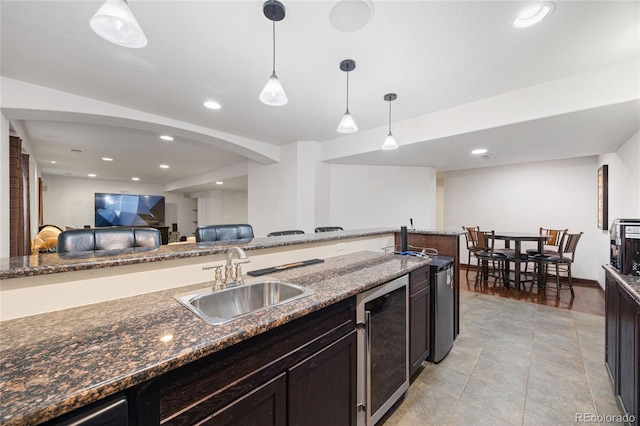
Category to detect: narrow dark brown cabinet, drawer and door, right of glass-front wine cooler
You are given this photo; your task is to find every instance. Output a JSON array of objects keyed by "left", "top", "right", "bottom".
[{"left": 409, "top": 266, "right": 431, "bottom": 376}]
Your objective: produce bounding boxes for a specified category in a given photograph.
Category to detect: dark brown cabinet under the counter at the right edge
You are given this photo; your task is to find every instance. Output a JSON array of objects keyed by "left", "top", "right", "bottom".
[{"left": 605, "top": 270, "right": 640, "bottom": 425}]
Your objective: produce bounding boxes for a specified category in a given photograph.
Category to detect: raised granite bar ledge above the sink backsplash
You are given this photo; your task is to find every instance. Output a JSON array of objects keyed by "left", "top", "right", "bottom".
[{"left": 0, "top": 228, "right": 464, "bottom": 280}]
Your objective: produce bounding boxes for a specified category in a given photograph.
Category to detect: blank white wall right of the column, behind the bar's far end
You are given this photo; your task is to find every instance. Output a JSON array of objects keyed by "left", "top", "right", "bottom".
[{"left": 328, "top": 165, "right": 436, "bottom": 229}]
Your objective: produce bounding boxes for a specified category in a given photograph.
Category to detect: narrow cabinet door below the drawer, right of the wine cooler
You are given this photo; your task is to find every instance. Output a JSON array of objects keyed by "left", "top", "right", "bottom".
[{"left": 409, "top": 285, "right": 431, "bottom": 375}]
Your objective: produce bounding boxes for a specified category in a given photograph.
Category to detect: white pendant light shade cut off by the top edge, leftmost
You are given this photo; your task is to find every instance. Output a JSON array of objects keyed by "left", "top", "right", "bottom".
[{"left": 89, "top": 0, "right": 147, "bottom": 48}]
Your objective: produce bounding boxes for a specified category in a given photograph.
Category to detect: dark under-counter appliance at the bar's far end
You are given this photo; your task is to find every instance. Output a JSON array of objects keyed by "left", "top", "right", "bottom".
[{"left": 427, "top": 255, "right": 454, "bottom": 363}]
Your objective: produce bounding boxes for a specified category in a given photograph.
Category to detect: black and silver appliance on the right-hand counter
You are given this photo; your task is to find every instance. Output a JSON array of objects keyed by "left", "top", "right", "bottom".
[{"left": 609, "top": 219, "right": 640, "bottom": 275}]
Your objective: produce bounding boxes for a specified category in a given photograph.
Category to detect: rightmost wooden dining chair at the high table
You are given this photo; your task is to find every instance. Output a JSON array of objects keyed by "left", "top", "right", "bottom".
[{"left": 529, "top": 232, "right": 583, "bottom": 299}]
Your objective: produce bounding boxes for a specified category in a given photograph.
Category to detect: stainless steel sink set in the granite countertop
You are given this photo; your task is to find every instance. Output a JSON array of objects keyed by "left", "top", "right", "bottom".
[{"left": 175, "top": 281, "right": 314, "bottom": 325}]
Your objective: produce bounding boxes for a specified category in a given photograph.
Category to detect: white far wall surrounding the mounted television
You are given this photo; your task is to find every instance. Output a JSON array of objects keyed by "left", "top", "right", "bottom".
[{"left": 42, "top": 175, "right": 196, "bottom": 236}]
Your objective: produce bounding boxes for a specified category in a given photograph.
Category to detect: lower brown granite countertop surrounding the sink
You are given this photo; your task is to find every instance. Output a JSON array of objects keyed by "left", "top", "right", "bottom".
[{"left": 0, "top": 251, "right": 430, "bottom": 425}]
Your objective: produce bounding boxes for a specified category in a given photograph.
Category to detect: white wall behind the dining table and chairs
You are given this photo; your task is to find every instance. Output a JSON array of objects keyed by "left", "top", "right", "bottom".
[{"left": 443, "top": 156, "right": 596, "bottom": 280}]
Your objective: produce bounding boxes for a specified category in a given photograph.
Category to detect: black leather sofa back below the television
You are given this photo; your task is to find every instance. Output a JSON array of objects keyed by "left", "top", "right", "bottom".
[{"left": 58, "top": 227, "right": 161, "bottom": 253}]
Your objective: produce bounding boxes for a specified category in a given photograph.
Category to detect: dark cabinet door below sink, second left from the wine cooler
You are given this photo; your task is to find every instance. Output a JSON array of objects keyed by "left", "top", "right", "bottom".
[{"left": 197, "top": 373, "right": 287, "bottom": 426}]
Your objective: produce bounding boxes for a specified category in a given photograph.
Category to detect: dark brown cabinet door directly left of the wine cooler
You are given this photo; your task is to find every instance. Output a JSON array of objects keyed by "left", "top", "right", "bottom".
[{"left": 287, "top": 331, "right": 357, "bottom": 426}]
